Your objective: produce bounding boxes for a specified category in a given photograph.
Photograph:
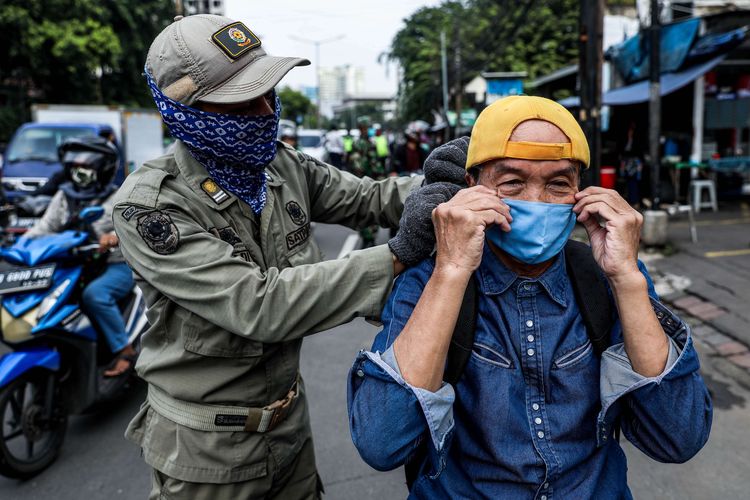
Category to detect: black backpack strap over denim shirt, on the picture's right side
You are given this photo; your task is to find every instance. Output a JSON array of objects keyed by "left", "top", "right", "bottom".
[{"left": 565, "top": 240, "right": 613, "bottom": 355}]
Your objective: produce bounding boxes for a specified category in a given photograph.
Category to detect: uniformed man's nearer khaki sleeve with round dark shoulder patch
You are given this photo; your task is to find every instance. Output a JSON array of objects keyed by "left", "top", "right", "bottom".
[{"left": 113, "top": 204, "right": 393, "bottom": 343}]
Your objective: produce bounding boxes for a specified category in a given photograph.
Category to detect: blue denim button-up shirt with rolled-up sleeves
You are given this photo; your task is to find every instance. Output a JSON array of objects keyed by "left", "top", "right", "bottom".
[{"left": 348, "top": 246, "right": 712, "bottom": 500}]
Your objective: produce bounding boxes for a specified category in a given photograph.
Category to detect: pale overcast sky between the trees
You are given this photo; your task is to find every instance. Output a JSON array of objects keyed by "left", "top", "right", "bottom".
[{"left": 225, "top": 0, "right": 441, "bottom": 93}]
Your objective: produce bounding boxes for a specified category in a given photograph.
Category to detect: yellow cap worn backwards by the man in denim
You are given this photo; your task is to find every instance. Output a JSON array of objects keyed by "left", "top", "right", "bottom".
[{"left": 466, "top": 95, "right": 589, "bottom": 170}]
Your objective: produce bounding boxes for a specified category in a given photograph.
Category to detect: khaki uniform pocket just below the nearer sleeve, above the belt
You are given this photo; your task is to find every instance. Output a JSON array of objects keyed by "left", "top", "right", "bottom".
[{"left": 182, "top": 317, "right": 263, "bottom": 358}]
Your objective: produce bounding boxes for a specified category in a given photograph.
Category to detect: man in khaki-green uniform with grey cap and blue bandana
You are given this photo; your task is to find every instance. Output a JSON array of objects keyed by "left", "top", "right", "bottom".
[{"left": 113, "top": 15, "right": 450, "bottom": 500}]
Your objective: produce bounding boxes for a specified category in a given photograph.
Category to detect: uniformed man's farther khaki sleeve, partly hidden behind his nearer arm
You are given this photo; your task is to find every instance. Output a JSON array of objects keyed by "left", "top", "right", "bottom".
[{"left": 300, "top": 153, "right": 423, "bottom": 229}]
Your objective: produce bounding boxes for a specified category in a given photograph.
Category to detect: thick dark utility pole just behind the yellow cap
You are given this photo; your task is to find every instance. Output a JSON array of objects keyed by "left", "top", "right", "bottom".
[{"left": 578, "top": 0, "right": 604, "bottom": 185}]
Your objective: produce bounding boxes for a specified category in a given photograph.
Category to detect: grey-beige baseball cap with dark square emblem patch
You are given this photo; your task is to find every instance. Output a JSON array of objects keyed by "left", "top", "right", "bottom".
[{"left": 146, "top": 14, "right": 310, "bottom": 106}]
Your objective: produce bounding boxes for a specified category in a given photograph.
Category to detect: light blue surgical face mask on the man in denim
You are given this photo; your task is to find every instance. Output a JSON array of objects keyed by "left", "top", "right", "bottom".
[{"left": 486, "top": 199, "right": 576, "bottom": 264}]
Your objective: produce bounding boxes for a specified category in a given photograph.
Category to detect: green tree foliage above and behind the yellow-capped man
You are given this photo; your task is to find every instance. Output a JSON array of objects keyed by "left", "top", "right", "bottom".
[{"left": 386, "top": 0, "right": 580, "bottom": 121}]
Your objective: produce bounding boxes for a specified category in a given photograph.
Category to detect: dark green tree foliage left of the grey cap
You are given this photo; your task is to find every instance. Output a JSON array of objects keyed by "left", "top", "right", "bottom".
[{"left": 0, "top": 0, "right": 174, "bottom": 137}]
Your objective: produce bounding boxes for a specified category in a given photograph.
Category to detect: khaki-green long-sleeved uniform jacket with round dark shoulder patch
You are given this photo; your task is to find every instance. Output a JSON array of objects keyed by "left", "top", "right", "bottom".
[{"left": 113, "top": 142, "right": 421, "bottom": 483}]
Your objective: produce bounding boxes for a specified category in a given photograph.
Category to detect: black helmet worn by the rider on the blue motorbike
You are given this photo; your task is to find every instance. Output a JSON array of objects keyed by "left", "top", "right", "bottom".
[{"left": 57, "top": 136, "right": 118, "bottom": 196}]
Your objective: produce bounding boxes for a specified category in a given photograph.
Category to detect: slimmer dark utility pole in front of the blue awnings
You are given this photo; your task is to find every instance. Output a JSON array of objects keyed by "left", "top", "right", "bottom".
[{"left": 648, "top": 0, "right": 661, "bottom": 206}]
